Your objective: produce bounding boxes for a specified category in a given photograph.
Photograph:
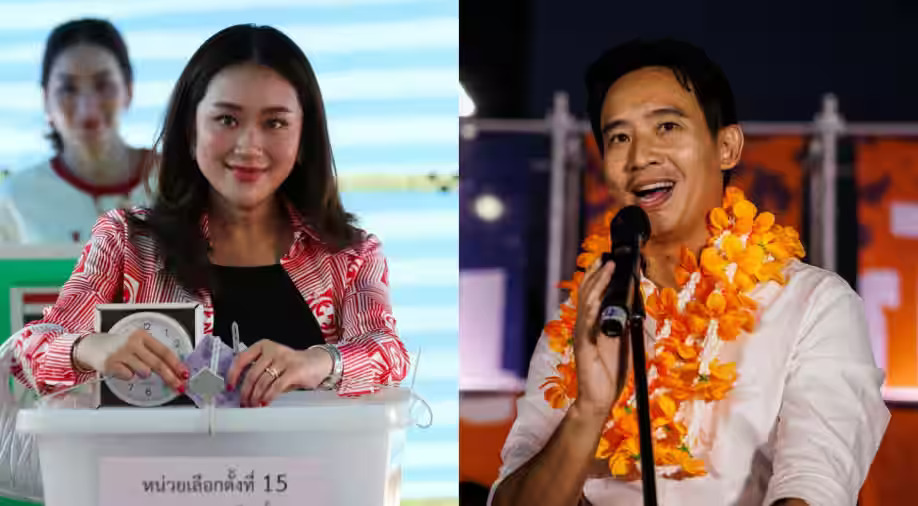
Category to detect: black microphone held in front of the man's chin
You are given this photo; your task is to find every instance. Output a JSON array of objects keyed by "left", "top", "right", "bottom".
[{"left": 599, "top": 206, "right": 650, "bottom": 337}]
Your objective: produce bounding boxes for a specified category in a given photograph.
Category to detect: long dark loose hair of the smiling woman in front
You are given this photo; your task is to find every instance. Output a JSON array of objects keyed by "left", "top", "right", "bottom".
[{"left": 129, "top": 24, "right": 359, "bottom": 291}]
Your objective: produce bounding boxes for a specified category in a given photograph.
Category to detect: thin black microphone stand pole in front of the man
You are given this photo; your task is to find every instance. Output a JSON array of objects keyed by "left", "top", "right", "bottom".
[{"left": 627, "top": 256, "right": 657, "bottom": 506}]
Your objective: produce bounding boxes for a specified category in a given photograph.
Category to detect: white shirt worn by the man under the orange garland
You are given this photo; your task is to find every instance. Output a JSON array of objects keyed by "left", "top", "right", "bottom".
[{"left": 492, "top": 261, "right": 890, "bottom": 506}]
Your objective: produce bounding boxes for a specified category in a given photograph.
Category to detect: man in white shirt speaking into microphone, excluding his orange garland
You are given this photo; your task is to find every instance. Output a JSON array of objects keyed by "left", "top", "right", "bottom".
[{"left": 491, "top": 40, "right": 889, "bottom": 506}]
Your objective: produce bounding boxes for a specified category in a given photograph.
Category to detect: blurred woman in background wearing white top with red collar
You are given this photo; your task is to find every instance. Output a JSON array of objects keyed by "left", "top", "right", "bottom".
[{"left": 0, "top": 19, "right": 155, "bottom": 243}]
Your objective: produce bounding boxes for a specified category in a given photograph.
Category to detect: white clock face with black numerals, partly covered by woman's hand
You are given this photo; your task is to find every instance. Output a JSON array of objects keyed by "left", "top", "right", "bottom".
[{"left": 105, "top": 311, "right": 193, "bottom": 407}]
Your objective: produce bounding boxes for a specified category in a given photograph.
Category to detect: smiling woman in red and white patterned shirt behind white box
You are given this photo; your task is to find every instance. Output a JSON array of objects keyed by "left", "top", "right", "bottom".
[{"left": 13, "top": 25, "right": 407, "bottom": 406}]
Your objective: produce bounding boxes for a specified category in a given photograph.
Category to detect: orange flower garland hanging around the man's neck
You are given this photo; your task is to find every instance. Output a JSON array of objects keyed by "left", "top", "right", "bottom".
[{"left": 542, "top": 187, "right": 804, "bottom": 481}]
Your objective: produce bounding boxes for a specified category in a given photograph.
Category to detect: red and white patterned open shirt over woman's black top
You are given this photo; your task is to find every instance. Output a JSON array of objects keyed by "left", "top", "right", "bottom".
[{"left": 11, "top": 206, "right": 408, "bottom": 395}]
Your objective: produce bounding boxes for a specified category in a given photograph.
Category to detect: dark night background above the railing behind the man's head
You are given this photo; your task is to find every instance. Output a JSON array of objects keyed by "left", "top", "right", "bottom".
[{"left": 459, "top": 0, "right": 918, "bottom": 121}]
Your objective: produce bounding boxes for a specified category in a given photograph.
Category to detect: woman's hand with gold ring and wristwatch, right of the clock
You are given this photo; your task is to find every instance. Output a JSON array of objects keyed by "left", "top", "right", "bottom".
[{"left": 226, "top": 339, "right": 333, "bottom": 407}]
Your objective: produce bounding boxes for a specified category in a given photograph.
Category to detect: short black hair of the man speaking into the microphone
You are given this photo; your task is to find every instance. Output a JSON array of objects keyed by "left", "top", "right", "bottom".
[{"left": 586, "top": 39, "right": 739, "bottom": 186}]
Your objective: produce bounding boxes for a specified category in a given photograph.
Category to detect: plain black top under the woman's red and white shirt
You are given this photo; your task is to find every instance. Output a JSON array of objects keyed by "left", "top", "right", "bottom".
[{"left": 213, "top": 264, "right": 325, "bottom": 350}]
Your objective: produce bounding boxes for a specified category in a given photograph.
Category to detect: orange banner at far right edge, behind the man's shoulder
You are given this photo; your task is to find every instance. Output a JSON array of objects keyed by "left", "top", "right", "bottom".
[{"left": 855, "top": 139, "right": 918, "bottom": 506}]
